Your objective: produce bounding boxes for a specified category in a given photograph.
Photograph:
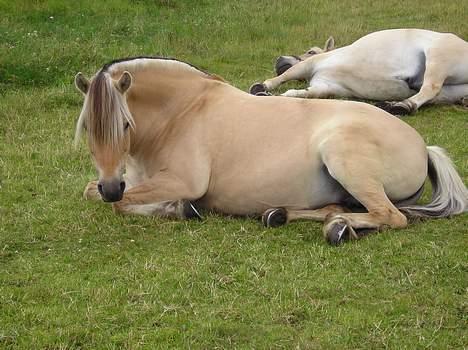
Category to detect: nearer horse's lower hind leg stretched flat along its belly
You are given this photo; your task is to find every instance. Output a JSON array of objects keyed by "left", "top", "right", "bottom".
[{"left": 262, "top": 204, "right": 348, "bottom": 227}]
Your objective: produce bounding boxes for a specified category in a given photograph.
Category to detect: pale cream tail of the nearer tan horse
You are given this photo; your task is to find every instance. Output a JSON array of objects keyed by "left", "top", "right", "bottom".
[{"left": 398, "top": 146, "right": 468, "bottom": 219}]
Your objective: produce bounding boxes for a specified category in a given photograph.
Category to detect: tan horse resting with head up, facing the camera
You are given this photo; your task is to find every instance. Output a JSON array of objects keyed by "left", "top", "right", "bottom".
[{"left": 75, "top": 58, "right": 468, "bottom": 244}]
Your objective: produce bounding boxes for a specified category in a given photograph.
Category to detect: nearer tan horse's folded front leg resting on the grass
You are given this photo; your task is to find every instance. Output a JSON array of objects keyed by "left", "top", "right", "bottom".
[{"left": 112, "top": 175, "right": 206, "bottom": 219}]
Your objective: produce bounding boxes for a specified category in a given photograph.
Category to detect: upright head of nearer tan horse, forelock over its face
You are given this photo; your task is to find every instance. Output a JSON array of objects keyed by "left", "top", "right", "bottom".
[{"left": 75, "top": 70, "right": 135, "bottom": 202}]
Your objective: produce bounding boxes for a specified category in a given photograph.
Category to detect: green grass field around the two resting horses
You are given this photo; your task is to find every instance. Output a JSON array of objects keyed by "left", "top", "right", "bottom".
[{"left": 0, "top": 0, "right": 468, "bottom": 349}]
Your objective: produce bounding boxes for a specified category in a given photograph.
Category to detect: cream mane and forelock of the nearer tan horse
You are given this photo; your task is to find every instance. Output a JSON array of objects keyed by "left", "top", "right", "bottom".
[{"left": 75, "top": 56, "right": 222, "bottom": 147}]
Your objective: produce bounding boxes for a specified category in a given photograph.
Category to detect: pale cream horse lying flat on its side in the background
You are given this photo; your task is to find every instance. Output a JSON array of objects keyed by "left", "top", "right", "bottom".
[{"left": 250, "top": 29, "right": 468, "bottom": 115}]
